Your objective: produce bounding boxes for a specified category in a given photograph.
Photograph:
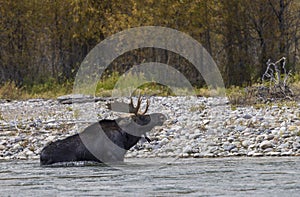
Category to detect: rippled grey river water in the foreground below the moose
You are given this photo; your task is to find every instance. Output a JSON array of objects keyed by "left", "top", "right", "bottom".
[{"left": 0, "top": 157, "right": 300, "bottom": 196}]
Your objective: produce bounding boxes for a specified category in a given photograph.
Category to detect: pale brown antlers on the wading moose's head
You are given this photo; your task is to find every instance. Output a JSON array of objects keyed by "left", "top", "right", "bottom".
[{"left": 107, "top": 94, "right": 150, "bottom": 116}]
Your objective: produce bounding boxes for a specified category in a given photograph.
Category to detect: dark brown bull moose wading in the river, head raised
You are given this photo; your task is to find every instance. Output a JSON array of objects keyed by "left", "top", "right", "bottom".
[{"left": 40, "top": 96, "right": 166, "bottom": 165}]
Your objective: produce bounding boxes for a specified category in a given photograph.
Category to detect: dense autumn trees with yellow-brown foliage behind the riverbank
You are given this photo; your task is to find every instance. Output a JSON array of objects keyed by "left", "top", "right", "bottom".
[{"left": 0, "top": 0, "right": 300, "bottom": 96}]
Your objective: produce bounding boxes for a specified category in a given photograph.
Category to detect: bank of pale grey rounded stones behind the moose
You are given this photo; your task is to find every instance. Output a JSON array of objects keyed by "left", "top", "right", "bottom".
[{"left": 0, "top": 97, "right": 300, "bottom": 160}]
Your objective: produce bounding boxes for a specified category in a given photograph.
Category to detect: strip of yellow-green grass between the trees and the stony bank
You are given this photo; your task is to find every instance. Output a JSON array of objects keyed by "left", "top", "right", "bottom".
[{"left": 0, "top": 72, "right": 300, "bottom": 104}]
